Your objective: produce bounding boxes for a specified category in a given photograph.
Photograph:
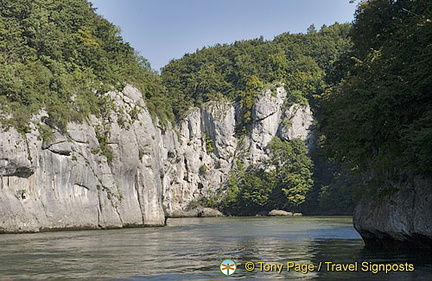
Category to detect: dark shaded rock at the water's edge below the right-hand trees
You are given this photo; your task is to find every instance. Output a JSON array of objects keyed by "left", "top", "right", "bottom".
[{"left": 353, "top": 176, "right": 432, "bottom": 249}]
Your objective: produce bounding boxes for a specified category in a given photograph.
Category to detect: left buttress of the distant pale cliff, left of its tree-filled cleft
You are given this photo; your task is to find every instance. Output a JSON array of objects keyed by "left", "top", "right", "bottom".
[{"left": 163, "top": 101, "right": 237, "bottom": 216}]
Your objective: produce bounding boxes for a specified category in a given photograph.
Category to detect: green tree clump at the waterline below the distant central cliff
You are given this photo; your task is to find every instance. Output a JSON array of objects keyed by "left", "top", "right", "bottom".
[{"left": 219, "top": 137, "right": 313, "bottom": 215}]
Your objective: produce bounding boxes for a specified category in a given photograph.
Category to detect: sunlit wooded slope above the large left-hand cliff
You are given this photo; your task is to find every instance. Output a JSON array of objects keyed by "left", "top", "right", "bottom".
[{"left": 0, "top": 0, "right": 173, "bottom": 133}]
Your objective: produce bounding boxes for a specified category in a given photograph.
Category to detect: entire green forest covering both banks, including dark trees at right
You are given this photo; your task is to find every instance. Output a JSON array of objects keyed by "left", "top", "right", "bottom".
[{"left": 0, "top": 0, "right": 432, "bottom": 215}]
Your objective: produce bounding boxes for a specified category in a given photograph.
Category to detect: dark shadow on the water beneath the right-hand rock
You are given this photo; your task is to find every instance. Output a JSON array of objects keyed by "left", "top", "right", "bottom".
[{"left": 311, "top": 239, "right": 432, "bottom": 281}]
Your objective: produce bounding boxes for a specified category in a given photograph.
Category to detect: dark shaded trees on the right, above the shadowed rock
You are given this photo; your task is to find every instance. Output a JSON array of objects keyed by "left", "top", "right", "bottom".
[{"left": 322, "top": 0, "right": 432, "bottom": 179}]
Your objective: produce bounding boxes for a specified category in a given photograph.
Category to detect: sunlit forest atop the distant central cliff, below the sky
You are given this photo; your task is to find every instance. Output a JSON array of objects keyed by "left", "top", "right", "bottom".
[{"left": 161, "top": 24, "right": 349, "bottom": 131}]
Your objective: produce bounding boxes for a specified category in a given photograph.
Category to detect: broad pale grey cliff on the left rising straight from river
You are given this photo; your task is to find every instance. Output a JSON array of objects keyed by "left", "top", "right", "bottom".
[{"left": 0, "top": 87, "right": 165, "bottom": 232}]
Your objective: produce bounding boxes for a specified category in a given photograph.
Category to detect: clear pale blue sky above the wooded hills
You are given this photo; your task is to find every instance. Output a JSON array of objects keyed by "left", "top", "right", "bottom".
[{"left": 90, "top": 0, "right": 356, "bottom": 70}]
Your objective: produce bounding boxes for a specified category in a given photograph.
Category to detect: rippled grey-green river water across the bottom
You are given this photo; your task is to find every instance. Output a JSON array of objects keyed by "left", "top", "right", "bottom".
[{"left": 0, "top": 217, "right": 432, "bottom": 281}]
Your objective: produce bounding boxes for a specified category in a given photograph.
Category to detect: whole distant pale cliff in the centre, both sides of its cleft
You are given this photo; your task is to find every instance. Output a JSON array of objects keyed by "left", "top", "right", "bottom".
[{"left": 163, "top": 87, "right": 313, "bottom": 216}]
